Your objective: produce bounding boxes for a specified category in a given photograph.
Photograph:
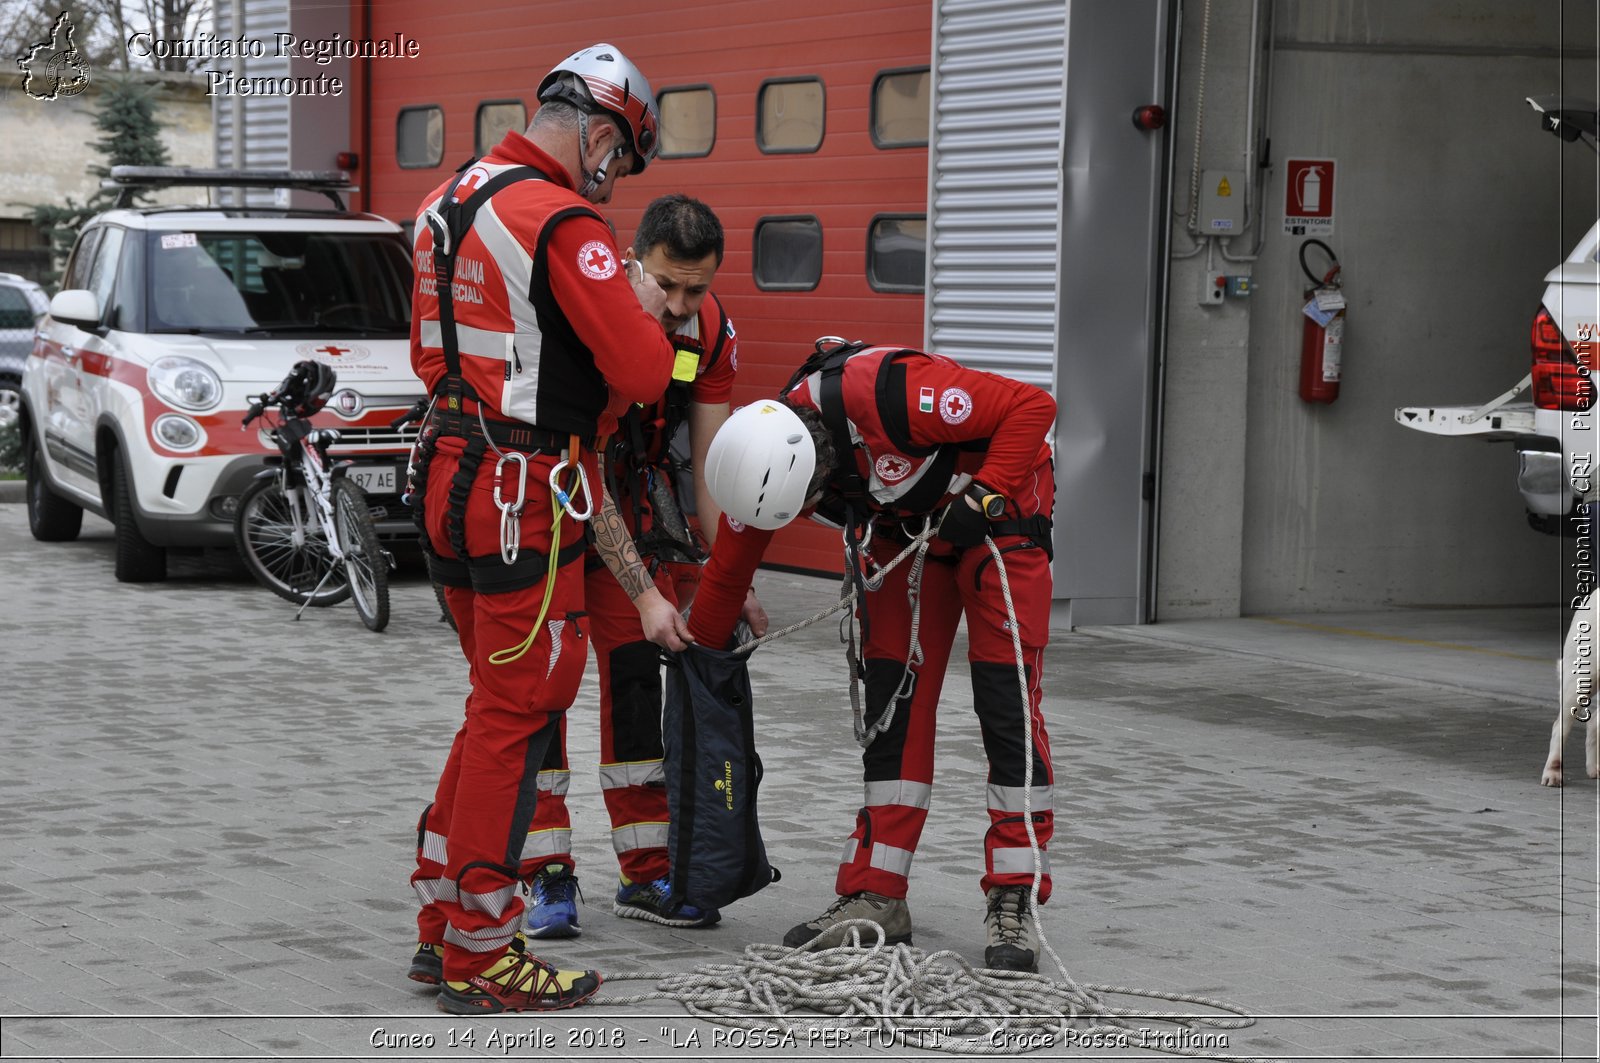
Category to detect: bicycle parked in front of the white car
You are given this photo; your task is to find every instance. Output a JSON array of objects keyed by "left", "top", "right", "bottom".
[{"left": 234, "top": 362, "right": 394, "bottom": 631}]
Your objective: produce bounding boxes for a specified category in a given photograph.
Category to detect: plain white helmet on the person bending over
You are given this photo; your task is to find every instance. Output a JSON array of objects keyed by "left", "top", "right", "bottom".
[{"left": 706, "top": 399, "right": 816, "bottom": 532}]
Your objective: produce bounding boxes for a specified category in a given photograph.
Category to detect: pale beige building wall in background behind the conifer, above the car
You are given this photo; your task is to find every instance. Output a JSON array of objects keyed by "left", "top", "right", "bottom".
[{"left": 0, "top": 70, "right": 213, "bottom": 218}]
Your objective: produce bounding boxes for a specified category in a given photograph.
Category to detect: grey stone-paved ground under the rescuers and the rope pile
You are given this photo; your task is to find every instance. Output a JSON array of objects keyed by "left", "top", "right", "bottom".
[{"left": 0, "top": 506, "right": 1600, "bottom": 1060}]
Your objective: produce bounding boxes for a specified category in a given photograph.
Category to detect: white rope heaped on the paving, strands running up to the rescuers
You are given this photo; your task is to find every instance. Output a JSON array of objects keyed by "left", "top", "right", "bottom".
[{"left": 595, "top": 525, "right": 1272, "bottom": 1063}]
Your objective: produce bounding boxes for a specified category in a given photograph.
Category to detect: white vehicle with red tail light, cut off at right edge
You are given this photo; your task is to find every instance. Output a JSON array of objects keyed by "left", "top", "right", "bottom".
[{"left": 1395, "top": 96, "right": 1600, "bottom": 533}]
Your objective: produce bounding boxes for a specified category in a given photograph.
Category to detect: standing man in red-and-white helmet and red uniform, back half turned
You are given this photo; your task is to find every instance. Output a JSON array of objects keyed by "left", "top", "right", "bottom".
[{"left": 410, "top": 45, "right": 682, "bottom": 1013}]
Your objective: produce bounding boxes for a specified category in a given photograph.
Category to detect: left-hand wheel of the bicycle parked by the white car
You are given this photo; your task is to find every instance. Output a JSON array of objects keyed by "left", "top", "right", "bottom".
[{"left": 234, "top": 477, "right": 350, "bottom": 605}]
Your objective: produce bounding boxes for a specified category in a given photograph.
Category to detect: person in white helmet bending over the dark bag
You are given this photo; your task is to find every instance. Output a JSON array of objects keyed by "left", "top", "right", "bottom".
[{"left": 690, "top": 341, "right": 1056, "bottom": 970}]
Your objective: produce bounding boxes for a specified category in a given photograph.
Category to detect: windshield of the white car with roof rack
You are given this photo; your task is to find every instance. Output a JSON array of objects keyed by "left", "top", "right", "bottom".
[{"left": 149, "top": 232, "right": 411, "bottom": 336}]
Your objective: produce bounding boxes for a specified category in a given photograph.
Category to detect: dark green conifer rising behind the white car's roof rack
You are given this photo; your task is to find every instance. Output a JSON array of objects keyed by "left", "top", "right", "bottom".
[{"left": 29, "top": 78, "right": 168, "bottom": 287}]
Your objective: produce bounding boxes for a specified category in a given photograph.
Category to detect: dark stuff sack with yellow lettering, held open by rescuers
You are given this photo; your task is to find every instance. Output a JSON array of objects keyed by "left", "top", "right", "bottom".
[{"left": 661, "top": 645, "right": 778, "bottom": 908}]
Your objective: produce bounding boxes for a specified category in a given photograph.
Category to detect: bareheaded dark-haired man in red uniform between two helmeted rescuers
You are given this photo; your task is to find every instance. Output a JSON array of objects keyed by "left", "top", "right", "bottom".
[{"left": 528, "top": 195, "right": 755, "bottom": 938}]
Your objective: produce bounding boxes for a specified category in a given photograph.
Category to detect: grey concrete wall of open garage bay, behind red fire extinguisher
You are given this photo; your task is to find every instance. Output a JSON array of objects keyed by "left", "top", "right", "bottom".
[{"left": 1157, "top": 0, "right": 1595, "bottom": 620}]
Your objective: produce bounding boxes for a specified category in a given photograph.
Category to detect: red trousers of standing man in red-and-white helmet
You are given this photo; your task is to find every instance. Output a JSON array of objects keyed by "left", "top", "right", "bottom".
[{"left": 411, "top": 439, "right": 598, "bottom": 981}]
